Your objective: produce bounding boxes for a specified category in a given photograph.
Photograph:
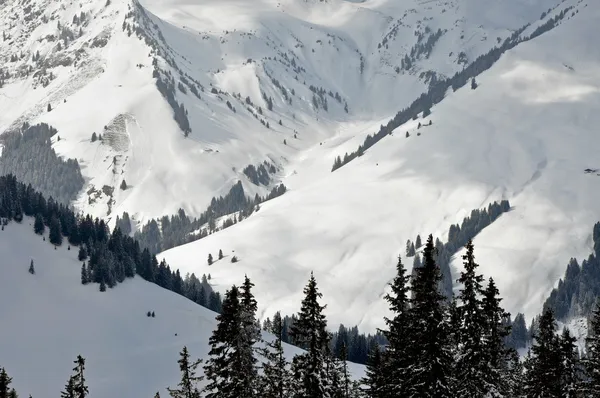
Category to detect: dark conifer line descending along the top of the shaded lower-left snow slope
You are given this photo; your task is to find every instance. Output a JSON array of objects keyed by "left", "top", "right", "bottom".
[{"left": 0, "top": 175, "right": 221, "bottom": 312}]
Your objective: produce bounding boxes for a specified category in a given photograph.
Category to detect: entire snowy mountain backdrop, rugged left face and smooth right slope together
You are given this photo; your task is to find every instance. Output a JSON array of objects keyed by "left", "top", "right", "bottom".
[{"left": 0, "top": 0, "right": 600, "bottom": 338}]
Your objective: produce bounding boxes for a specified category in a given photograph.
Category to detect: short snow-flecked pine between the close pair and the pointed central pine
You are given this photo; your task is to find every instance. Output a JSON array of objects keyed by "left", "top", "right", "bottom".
[{"left": 259, "top": 312, "right": 291, "bottom": 398}]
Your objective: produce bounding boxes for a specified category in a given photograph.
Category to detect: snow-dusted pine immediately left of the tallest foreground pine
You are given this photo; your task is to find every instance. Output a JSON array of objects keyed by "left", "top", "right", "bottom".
[{"left": 379, "top": 256, "right": 411, "bottom": 396}]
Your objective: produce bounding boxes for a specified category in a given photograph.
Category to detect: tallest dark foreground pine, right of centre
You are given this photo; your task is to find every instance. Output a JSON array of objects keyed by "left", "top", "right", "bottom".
[{"left": 407, "top": 235, "right": 455, "bottom": 398}]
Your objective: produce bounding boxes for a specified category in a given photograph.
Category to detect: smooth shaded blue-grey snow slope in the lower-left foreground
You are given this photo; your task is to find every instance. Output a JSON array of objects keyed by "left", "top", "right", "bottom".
[{"left": 0, "top": 220, "right": 362, "bottom": 398}]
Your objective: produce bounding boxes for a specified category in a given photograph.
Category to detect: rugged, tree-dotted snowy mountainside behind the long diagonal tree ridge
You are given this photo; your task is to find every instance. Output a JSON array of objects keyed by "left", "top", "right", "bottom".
[{"left": 0, "top": 0, "right": 559, "bottom": 221}]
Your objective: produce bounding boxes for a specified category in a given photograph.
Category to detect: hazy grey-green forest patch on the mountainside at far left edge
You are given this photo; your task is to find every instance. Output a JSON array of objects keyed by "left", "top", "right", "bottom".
[{"left": 0, "top": 124, "right": 84, "bottom": 204}]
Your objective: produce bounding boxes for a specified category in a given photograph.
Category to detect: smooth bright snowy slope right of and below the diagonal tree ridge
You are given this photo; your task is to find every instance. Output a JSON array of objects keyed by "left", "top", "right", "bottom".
[{"left": 163, "top": 1, "right": 600, "bottom": 330}]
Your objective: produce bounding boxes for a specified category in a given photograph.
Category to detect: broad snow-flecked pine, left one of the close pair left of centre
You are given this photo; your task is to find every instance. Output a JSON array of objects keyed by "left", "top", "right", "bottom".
[{"left": 204, "top": 285, "right": 246, "bottom": 398}]
